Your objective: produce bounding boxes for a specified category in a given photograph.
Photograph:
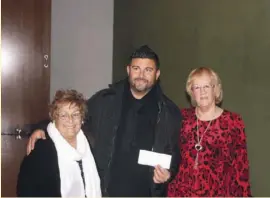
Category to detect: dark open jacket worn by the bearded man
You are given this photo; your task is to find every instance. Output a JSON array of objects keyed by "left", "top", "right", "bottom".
[{"left": 83, "top": 80, "right": 181, "bottom": 196}]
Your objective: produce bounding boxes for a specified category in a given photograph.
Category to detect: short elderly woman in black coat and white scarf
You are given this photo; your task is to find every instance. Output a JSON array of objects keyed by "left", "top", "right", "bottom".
[{"left": 17, "top": 90, "right": 101, "bottom": 197}]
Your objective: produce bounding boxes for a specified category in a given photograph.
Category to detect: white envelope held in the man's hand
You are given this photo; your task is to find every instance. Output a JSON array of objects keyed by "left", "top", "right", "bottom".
[{"left": 138, "top": 150, "right": 172, "bottom": 169}]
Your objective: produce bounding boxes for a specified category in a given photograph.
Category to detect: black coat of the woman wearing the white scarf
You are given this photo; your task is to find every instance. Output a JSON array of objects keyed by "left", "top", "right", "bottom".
[{"left": 17, "top": 133, "right": 61, "bottom": 197}]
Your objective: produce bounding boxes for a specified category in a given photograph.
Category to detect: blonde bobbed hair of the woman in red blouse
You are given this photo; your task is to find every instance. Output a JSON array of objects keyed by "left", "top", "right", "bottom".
[{"left": 186, "top": 67, "right": 223, "bottom": 106}]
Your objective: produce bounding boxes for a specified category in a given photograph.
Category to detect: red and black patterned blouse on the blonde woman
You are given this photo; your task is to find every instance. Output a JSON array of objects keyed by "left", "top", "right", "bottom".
[{"left": 168, "top": 108, "right": 251, "bottom": 197}]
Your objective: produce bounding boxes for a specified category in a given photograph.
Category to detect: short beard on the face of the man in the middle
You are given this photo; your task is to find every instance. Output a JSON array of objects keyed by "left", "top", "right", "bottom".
[{"left": 129, "top": 78, "right": 156, "bottom": 93}]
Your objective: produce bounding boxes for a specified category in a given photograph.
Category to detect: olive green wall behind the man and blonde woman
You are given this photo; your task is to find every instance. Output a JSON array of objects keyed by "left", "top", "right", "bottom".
[{"left": 113, "top": 0, "right": 270, "bottom": 196}]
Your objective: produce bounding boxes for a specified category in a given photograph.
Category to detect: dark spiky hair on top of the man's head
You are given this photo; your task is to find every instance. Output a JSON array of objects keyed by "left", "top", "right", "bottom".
[{"left": 129, "top": 45, "right": 160, "bottom": 69}]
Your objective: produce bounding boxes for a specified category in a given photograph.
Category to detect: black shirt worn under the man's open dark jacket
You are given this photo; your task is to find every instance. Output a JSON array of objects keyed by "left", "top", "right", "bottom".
[{"left": 108, "top": 81, "right": 158, "bottom": 197}]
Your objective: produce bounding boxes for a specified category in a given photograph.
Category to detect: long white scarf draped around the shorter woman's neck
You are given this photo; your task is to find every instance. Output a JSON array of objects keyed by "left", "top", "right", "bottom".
[{"left": 47, "top": 122, "right": 101, "bottom": 197}]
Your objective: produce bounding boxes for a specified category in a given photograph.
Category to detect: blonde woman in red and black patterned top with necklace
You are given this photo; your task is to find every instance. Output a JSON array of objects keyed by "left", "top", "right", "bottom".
[{"left": 168, "top": 67, "right": 251, "bottom": 197}]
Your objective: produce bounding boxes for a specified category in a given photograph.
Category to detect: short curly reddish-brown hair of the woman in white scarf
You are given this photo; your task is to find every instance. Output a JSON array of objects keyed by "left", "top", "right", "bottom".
[{"left": 49, "top": 89, "right": 87, "bottom": 120}]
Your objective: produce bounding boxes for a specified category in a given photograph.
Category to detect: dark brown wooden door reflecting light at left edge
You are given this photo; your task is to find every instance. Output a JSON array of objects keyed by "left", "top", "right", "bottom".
[{"left": 1, "top": 0, "right": 51, "bottom": 197}]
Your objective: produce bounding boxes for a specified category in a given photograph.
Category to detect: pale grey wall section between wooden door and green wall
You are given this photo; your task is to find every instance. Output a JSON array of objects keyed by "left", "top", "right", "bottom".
[{"left": 51, "top": 0, "right": 114, "bottom": 98}]
